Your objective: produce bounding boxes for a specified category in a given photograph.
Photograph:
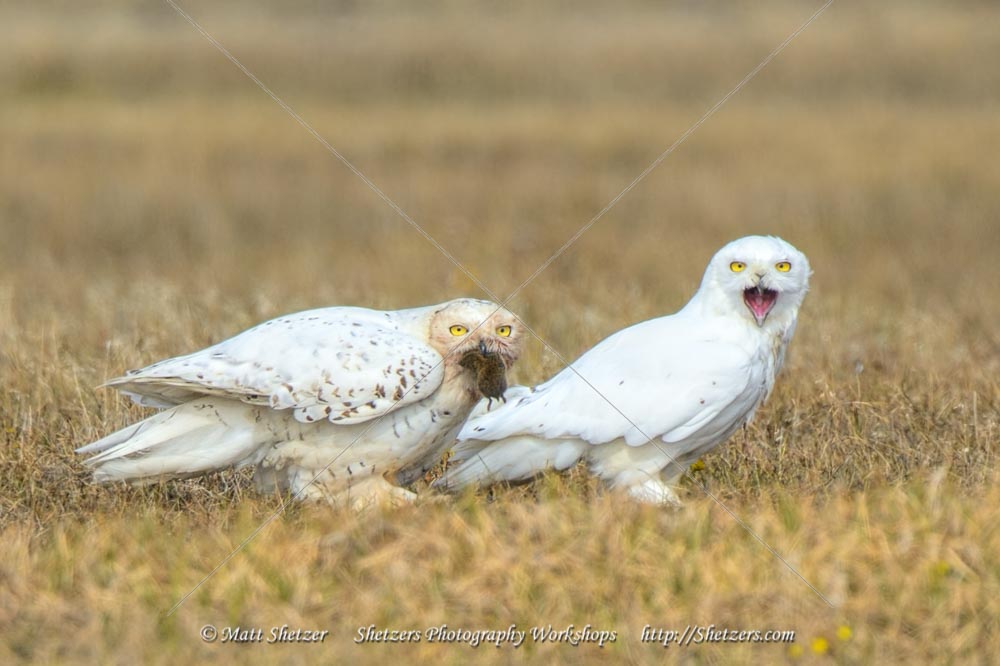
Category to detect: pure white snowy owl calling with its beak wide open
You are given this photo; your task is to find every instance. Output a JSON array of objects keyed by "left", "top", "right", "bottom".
[{"left": 435, "top": 236, "right": 810, "bottom": 503}]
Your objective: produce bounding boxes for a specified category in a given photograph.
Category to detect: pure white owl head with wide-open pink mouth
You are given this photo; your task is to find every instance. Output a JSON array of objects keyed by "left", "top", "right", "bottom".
[{"left": 698, "top": 236, "right": 811, "bottom": 330}]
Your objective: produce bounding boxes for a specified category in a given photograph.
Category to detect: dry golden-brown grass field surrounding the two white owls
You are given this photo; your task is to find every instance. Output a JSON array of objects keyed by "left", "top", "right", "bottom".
[{"left": 0, "top": 0, "right": 1000, "bottom": 664}]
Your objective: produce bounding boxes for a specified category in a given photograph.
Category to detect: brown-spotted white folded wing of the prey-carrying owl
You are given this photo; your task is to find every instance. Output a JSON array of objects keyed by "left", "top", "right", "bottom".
[{"left": 105, "top": 307, "right": 444, "bottom": 424}]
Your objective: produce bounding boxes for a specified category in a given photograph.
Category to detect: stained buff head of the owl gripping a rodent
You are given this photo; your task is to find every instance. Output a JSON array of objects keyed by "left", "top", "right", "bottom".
[{"left": 429, "top": 298, "right": 524, "bottom": 369}]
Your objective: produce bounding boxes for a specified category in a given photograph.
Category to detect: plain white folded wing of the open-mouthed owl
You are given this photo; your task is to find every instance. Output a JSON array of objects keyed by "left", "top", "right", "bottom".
[{"left": 458, "top": 315, "right": 763, "bottom": 446}]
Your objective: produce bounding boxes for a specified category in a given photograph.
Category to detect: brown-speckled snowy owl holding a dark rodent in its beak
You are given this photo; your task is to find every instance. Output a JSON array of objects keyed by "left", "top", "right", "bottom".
[{"left": 78, "top": 299, "right": 523, "bottom": 506}]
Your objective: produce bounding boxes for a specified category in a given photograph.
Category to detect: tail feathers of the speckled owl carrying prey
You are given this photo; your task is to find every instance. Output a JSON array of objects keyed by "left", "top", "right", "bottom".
[{"left": 76, "top": 398, "right": 272, "bottom": 484}]
